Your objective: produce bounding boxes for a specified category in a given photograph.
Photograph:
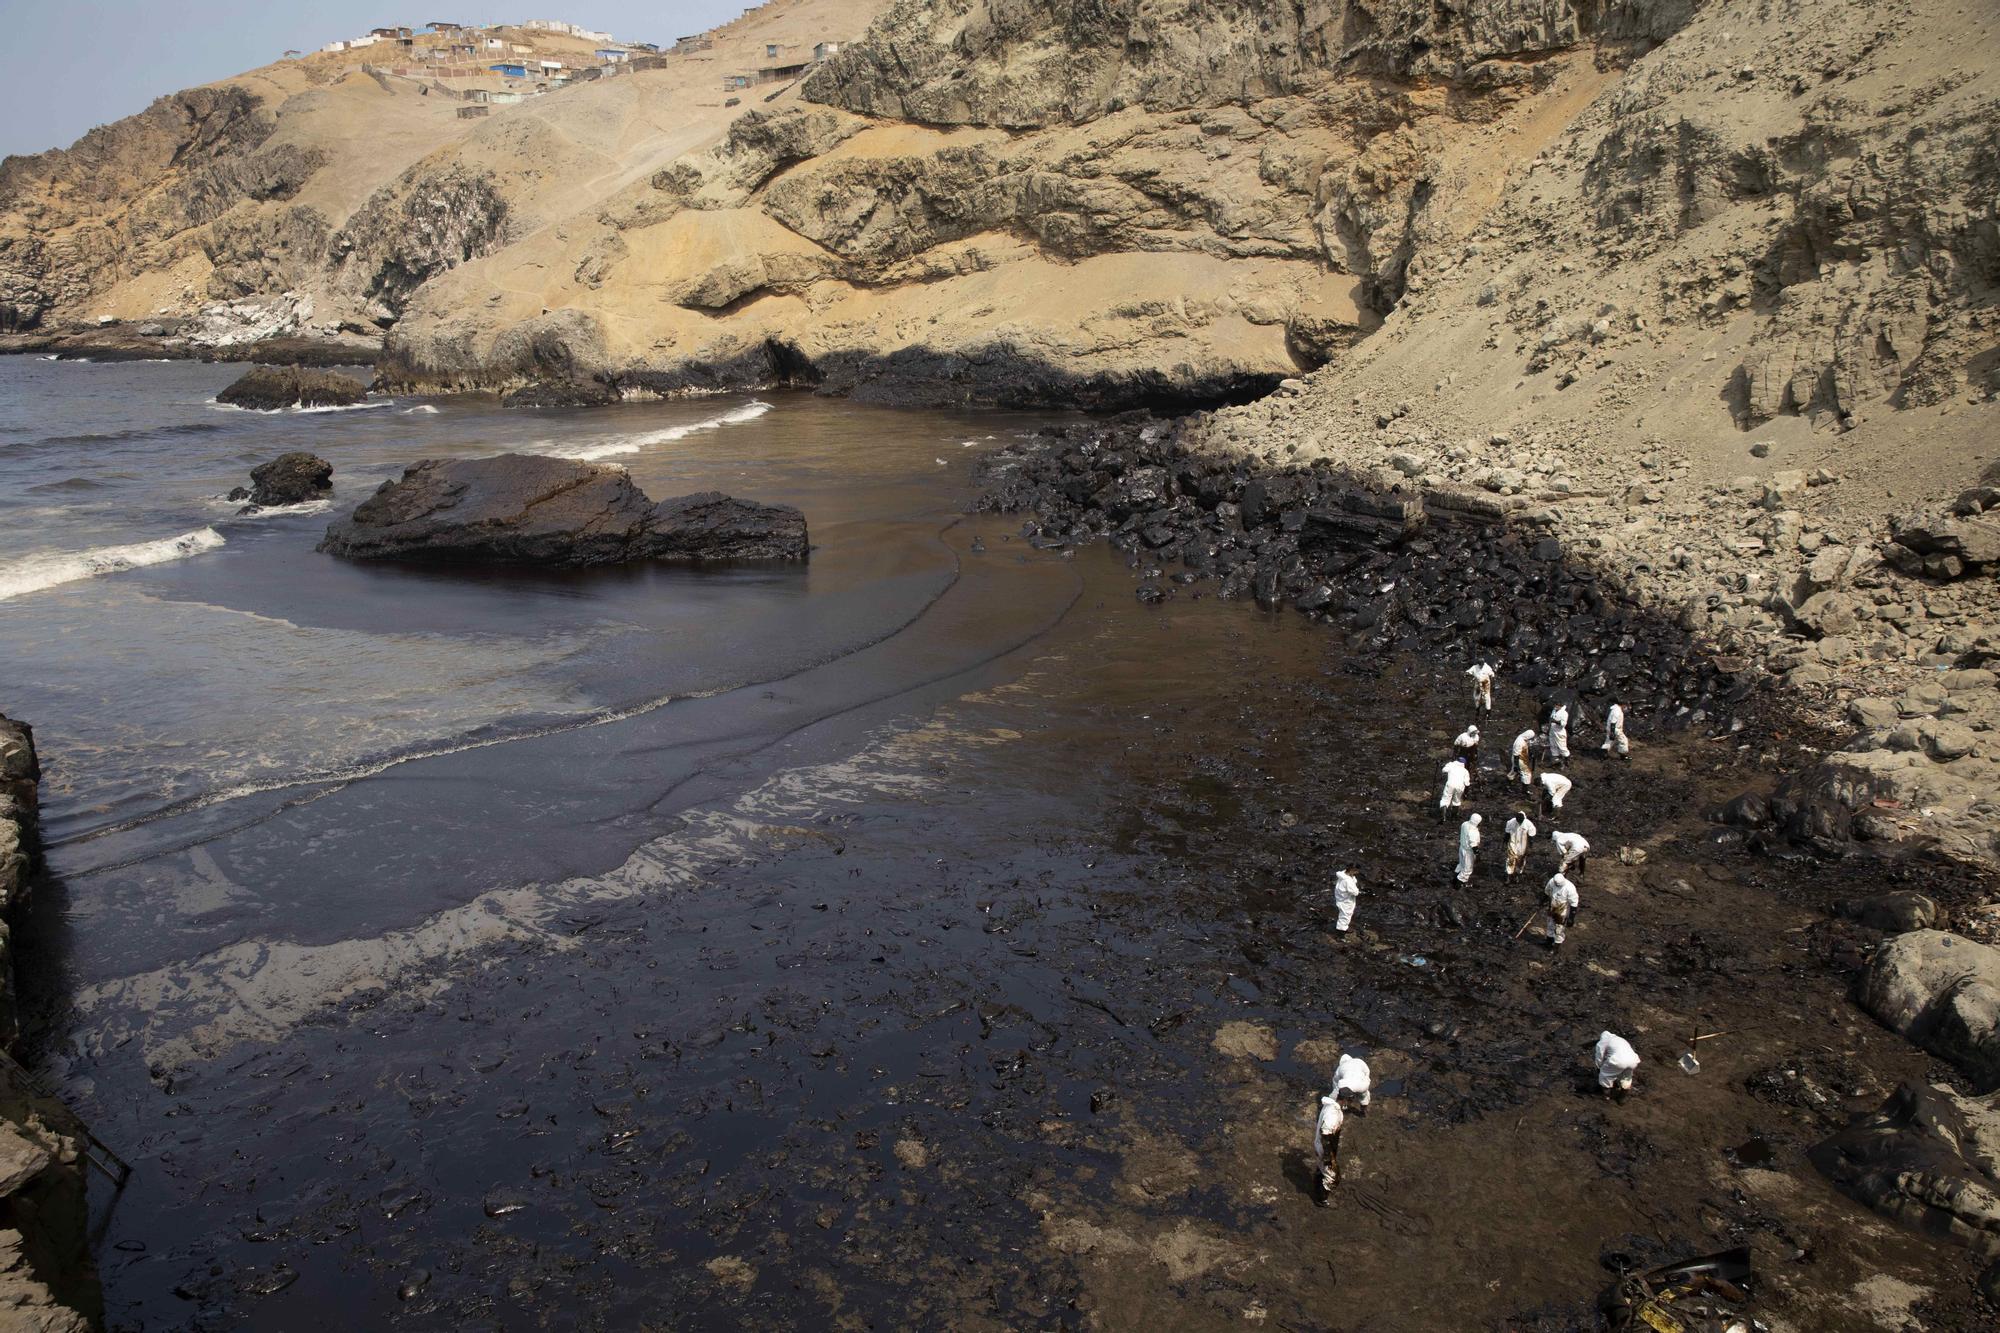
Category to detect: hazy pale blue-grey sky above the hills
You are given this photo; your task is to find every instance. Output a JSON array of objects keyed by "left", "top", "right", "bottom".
[{"left": 0, "top": 0, "right": 754, "bottom": 156}]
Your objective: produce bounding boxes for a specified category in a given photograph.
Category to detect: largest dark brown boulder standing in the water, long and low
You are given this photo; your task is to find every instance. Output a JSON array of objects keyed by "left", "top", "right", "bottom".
[{"left": 320, "top": 454, "right": 806, "bottom": 568}]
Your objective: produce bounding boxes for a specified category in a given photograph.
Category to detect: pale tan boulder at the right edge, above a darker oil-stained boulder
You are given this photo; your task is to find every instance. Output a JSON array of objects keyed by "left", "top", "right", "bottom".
[{"left": 1860, "top": 931, "right": 2000, "bottom": 1091}]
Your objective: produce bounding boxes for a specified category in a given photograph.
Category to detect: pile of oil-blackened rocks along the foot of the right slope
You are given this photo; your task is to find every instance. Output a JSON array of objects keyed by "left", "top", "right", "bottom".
[{"left": 978, "top": 414, "right": 1764, "bottom": 729}]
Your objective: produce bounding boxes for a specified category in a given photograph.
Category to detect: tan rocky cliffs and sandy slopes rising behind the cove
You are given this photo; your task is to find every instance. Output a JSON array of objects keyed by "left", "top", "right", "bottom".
[{"left": 0, "top": 0, "right": 2000, "bottom": 422}]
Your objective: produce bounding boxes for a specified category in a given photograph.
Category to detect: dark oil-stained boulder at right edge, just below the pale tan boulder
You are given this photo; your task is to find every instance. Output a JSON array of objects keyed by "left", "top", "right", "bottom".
[{"left": 1808, "top": 1083, "right": 2000, "bottom": 1285}]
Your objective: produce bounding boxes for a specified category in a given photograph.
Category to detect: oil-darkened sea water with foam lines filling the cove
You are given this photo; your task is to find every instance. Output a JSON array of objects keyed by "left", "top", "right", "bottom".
[{"left": 0, "top": 358, "right": 1392, "bottom": 1329}]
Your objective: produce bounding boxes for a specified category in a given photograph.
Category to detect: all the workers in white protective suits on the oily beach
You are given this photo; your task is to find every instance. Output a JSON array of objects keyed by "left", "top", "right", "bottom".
[{"left": 1312, "top": 662, "right": 1638, "bottom": 1207}]
